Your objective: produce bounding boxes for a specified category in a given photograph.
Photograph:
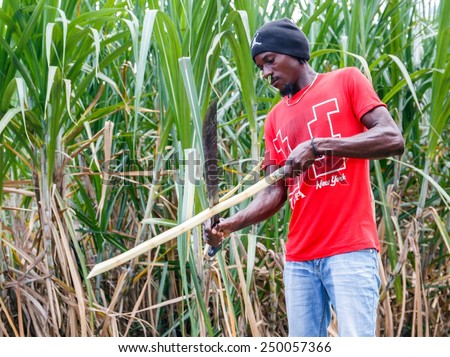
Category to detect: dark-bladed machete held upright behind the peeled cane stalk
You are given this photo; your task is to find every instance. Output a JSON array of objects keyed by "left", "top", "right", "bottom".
[{"left": 202, "top": 99, "right": 222, "bottom": 257}]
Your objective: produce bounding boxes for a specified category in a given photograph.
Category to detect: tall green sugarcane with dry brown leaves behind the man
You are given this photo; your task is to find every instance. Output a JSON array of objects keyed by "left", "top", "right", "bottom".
[{"left": 0, "top": 0, "right": 450, "bottom": 336}]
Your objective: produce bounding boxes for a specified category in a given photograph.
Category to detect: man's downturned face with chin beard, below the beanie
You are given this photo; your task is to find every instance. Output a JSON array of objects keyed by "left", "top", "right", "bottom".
[{"left": 255, "top": 52, "right": 302, "bottom": 96}]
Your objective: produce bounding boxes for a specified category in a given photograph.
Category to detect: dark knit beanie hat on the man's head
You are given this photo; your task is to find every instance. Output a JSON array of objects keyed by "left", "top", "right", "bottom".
[{"left": 251, "top": 18, "right": 310, "bottom": 61}]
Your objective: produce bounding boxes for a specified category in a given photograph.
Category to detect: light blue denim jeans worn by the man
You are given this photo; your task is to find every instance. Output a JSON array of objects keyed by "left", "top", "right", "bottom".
[{"left": 284, "top": 249, "right": 380, "bottom": 337}]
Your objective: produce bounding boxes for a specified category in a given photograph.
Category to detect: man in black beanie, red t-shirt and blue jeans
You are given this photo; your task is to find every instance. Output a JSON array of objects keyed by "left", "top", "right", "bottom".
[{"left": 205, "top": 19, "right": 404, "bottom": 336}]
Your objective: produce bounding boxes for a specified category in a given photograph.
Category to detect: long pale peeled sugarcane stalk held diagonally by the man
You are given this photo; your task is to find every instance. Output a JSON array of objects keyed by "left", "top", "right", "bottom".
[{"left": 87, "top": 168, "right": 284, "bottom": 279}]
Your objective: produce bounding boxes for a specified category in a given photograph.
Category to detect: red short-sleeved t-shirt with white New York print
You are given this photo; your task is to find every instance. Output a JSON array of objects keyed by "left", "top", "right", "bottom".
[{"left": 264, "top": 68, "right": 386, "bottom": 261}]
